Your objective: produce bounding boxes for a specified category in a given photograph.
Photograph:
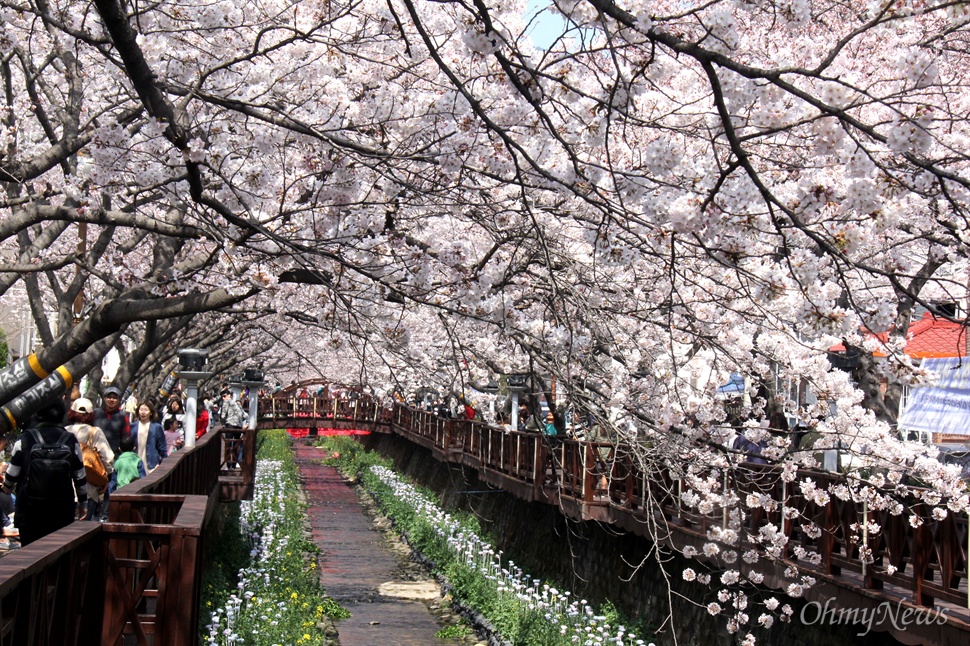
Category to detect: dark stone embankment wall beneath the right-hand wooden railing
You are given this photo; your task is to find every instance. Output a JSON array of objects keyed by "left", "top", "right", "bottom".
[{"left": 364, "top": 434, "right": 899, "bottom": 646}]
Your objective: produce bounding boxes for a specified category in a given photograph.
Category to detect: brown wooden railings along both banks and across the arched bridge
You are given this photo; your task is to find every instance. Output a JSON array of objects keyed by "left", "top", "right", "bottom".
[{"left": 0, "top": 389, "right": 970, "bottom": 646}]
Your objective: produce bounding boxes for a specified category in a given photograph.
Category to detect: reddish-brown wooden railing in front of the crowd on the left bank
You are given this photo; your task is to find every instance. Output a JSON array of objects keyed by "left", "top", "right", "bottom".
[{"left": 0, "top": 429, "right": 256, "bottom": 646}]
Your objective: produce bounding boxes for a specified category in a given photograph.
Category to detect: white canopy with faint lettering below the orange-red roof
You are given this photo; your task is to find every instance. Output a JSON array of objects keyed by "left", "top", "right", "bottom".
[{"left": 899, "top": 357, "right": 970, "bottom": 435}]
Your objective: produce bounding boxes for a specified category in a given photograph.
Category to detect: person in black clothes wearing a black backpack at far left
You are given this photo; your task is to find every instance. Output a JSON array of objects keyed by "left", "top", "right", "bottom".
[{"left": 3, "top": 399, "right": 88, "bottom": 545}]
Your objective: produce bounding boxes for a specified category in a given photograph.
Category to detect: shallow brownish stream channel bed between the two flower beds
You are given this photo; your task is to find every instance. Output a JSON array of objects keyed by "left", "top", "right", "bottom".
[{"left": 293, "top": 440, "right": 486, "bottom": 646}]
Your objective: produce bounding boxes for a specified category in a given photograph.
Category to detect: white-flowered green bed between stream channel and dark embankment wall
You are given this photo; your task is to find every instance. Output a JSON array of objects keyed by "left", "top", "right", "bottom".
[{"left": 362, "top": 465, "right": 644, "bottom": 646}]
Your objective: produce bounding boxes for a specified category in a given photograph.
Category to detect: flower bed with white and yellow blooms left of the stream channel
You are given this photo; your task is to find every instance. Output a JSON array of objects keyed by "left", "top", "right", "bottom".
[{"left": 203, "top": 431, "right": 348, "bottom": 645}]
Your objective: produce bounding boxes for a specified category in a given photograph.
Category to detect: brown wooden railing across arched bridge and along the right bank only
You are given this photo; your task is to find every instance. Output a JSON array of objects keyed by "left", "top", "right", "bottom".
[{"left": 260, "top": 397, "right": 970, "bottom": 632}]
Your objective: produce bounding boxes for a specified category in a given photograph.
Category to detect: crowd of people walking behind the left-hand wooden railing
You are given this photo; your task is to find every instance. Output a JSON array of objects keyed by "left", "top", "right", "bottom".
[{"left": 0, "top": 384, "right": 253, "bottom": 551}]
